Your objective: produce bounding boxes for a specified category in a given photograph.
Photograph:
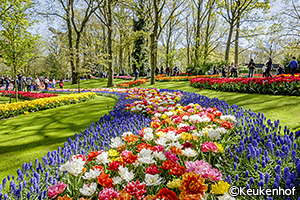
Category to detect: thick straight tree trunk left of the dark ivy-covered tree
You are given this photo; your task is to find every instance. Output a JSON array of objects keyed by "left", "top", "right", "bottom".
[{"left": 107, "top": 0, "right": 114, "bottom": 87}]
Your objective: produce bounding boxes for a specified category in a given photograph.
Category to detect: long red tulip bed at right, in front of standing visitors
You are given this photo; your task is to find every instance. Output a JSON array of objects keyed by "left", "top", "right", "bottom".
[{"left": 191, "top": 76, "right": 300, "bottom": 96}]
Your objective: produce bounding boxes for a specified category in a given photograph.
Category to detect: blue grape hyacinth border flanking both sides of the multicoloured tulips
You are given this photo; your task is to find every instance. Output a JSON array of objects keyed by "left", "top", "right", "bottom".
[{"left": 0, "top": 89, "right": 300, "bottom": 200}]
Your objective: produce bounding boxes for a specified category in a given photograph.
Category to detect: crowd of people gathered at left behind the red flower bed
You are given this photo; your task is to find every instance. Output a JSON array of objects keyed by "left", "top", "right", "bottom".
[{"left": 0, "top": 75, "right": 64, "bottom": 92}]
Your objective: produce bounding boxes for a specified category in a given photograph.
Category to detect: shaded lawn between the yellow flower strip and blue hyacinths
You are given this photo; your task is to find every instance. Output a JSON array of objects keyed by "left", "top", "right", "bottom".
[{"left": 0, "top": 96, "right": 116, "bottom": 180}]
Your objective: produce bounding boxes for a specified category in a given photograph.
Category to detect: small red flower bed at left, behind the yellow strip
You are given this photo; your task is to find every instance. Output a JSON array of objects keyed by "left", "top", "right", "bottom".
[{"left": 0, "top": 90, "right": 57, "bottom": 100}]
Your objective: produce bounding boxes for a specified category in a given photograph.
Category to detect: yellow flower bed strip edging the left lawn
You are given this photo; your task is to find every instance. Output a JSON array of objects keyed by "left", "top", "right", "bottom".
[{"left": 0, "top": 92, "right": 96, "bottom": 119}]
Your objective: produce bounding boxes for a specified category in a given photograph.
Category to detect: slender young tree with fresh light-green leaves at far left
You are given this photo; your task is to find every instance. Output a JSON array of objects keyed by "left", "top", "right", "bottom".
[{"left": 0, "top": 0, "right": 37, "bottom": 101}]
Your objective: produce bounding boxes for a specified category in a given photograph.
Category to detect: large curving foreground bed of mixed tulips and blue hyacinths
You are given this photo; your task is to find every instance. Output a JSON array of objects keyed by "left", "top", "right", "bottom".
[{"left": 0, "top": 88, "right": 300, "bottom": 200}]
